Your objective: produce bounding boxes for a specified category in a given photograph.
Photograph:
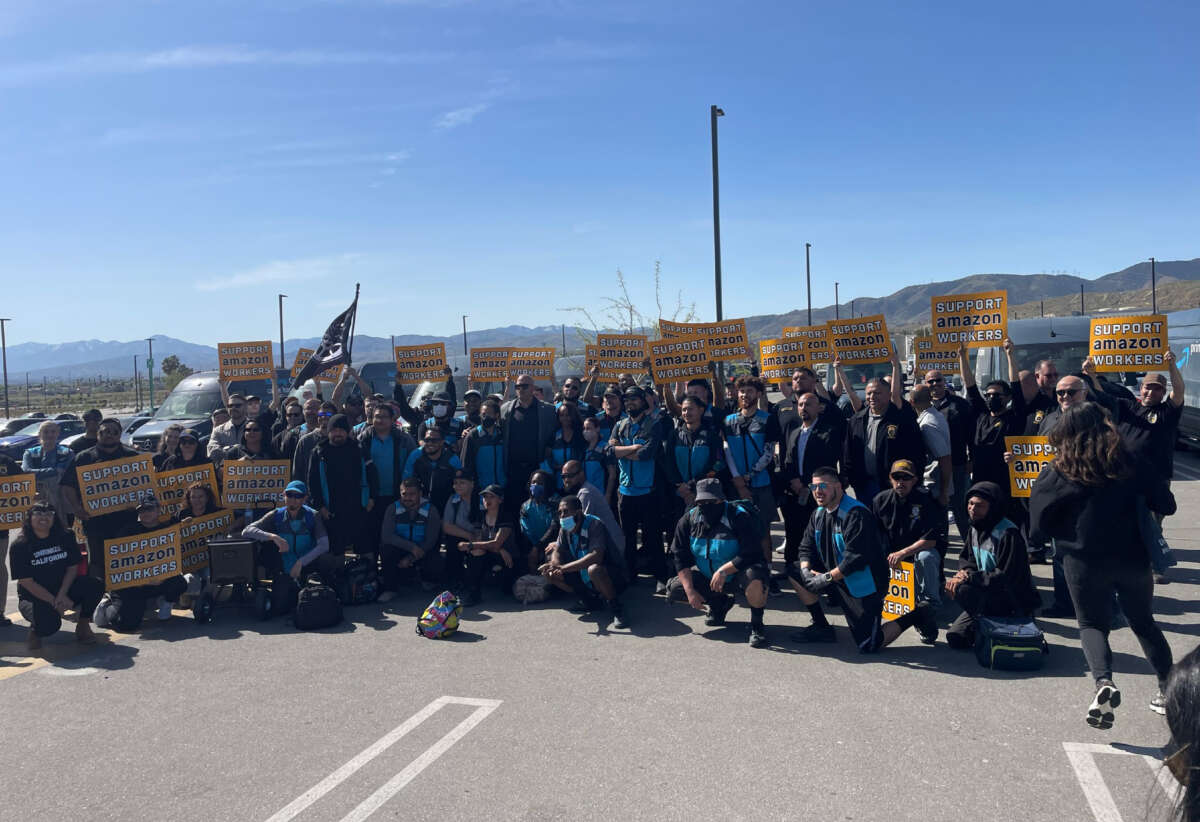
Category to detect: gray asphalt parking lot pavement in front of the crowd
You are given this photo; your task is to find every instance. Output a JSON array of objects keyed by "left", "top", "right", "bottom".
[{"left": 0, "top": 454, "right": 1200, "bottom": 822}]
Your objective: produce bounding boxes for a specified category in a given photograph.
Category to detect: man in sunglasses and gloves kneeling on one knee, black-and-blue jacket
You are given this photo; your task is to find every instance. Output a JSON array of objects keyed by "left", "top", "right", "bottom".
[{"left": 788, "top": 468, "right": 937, "bottom": 654}]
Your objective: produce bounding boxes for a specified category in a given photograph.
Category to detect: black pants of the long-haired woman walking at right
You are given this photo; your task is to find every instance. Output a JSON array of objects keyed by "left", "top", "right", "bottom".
[{"left": 1062, "top": 553, "right": 1171, "bottom": 688}]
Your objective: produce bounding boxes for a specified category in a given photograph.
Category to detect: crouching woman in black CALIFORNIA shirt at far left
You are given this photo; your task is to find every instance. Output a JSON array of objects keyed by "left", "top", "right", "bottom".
[{"left": 8, "top": 502, "right": 104, "bottom": 650}]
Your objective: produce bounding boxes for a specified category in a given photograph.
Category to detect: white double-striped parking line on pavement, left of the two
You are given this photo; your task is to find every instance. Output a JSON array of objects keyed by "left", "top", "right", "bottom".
[{"left": 266, "top": 696, "right": 500, "bottom": 822}]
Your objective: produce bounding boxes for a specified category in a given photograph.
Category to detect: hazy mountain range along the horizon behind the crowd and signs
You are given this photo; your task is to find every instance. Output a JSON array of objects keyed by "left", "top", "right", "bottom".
[{"left": 8, "top": 258, "right": 1200, "bottom": 383}]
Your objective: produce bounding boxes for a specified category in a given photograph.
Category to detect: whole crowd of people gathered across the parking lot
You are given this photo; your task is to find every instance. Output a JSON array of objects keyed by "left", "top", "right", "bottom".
[{"left": 0, "top": 340, "right": 1184, "bottom": 727}]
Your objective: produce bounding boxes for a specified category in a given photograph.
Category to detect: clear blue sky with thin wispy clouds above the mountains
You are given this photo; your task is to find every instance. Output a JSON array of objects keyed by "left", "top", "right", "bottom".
[{"left": 0, "top": 0, "right": 1200, "bottom": 343}]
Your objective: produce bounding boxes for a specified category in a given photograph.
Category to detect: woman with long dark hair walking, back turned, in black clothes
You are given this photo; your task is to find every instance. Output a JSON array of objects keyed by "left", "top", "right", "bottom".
[{"left": 1030, "top": 402, "right": 1175, "bottom": 730}]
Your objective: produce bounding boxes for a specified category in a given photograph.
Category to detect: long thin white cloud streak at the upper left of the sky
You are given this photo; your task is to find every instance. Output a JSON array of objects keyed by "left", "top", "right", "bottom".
[{"left": 0, "top": 44, "right": 454, "bottom": 86}]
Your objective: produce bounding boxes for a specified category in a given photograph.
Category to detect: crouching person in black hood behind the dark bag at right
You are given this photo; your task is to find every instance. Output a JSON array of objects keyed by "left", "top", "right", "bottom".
[{"left": 946, "top": 482, "right": 1039, "bottom": 649}]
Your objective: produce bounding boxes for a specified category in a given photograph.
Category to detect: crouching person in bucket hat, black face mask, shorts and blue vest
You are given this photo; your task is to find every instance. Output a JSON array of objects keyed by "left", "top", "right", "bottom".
[{"left": 671, "top": 479, "right": 770, "bottom": 648}]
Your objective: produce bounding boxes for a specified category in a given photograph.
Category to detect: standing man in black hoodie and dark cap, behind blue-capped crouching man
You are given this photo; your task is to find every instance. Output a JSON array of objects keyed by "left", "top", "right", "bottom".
[{"left": 308, "top": 414, "right": 378, "bottom": 554}]
